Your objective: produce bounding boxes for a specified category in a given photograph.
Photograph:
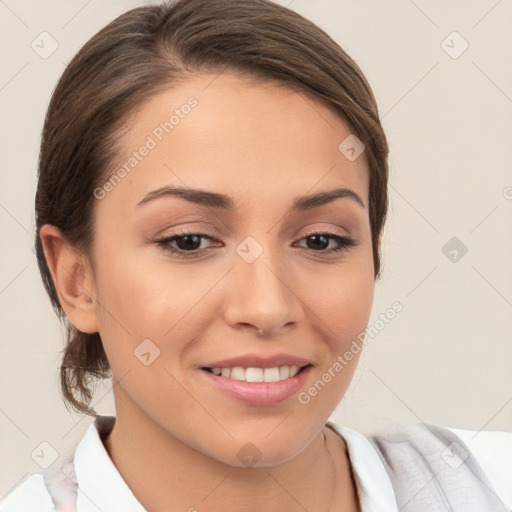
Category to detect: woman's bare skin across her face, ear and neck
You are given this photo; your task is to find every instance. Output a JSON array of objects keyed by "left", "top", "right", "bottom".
[{"left": 41, "top": 73, "right": 374, "bottom": 512}]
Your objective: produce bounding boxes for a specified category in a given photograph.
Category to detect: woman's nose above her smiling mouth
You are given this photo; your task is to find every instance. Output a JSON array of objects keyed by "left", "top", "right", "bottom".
[{"left": 224, "top": 245, "right": 304, "bottom": 336}]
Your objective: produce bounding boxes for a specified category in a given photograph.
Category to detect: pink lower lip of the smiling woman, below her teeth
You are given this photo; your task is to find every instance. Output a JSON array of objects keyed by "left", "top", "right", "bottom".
[{"left": 200, "top": 366, "right": 312, "bottom": 407}]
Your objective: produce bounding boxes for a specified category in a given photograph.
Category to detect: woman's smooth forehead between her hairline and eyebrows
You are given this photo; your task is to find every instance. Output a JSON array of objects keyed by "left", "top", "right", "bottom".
[{"left": 98, "top": 73, "right": 368, "bottom": 213}]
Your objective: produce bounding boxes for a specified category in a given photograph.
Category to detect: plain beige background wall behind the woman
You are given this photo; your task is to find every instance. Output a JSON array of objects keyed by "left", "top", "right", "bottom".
[{"left": 0, "top": 0, "right": 512, "bottom": 498}]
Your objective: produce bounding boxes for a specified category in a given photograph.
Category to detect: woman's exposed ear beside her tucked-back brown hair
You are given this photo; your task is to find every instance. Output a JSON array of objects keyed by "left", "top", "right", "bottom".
[{"left": 39, "top": 224, "right": 98, "bottom": 333}]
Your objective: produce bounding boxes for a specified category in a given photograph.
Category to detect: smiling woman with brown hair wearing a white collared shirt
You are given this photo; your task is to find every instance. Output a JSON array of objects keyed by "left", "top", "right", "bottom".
[{"left": 0, "top": 0, "right": 512, "bottom": 512}]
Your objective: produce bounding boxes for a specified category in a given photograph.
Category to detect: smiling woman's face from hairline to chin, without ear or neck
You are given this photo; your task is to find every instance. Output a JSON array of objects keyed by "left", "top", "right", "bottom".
[{"left": 87, "top": 74, "right": 374, "bottom": 466}]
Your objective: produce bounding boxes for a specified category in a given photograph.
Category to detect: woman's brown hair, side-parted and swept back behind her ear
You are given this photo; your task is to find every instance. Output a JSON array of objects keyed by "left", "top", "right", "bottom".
[{"left": 35, "top": 0, "right": 388, "bottom": 415}]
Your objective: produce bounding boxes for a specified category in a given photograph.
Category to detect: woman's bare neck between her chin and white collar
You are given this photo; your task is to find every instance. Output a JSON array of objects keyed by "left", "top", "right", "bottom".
[{"left": 104, "top": 390, "right": 359, "bottom": 512}]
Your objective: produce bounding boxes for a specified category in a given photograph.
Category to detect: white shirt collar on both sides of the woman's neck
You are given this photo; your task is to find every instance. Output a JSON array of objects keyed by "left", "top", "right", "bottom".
[{"left": 74, "top": 416, "right": 398, "bottom": 512}]
